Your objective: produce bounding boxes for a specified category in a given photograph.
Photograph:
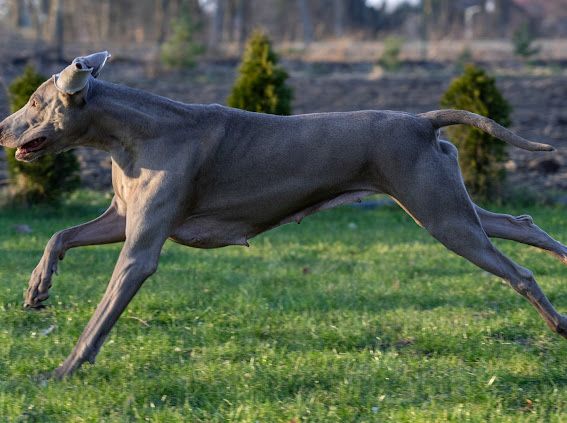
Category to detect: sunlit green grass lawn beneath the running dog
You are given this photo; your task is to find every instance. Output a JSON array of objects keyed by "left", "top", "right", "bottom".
[{"left": 0, "top": 193, "right": 567, "bottom": 423}]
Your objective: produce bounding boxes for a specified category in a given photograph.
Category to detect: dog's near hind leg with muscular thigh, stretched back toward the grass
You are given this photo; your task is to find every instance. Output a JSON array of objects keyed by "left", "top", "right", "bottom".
[{"left": 396, "top": 155, "right": 567, "bottom": 337}]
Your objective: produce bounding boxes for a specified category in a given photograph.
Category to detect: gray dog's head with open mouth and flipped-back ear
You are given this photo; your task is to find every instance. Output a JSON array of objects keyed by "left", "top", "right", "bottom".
[{"left": 0, "top": 51, "right": 110, "bottom": 162}]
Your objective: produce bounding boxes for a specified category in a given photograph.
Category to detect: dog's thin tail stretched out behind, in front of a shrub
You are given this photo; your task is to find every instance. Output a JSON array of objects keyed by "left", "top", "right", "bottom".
[{"left": 418, "top": 109, "right": 555, "bottom": 151}]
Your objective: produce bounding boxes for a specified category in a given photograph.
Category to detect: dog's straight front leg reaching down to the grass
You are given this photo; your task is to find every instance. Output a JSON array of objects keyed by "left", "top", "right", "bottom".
[{"left": 54, "top": 192, "right": 176, "bottom": 379}]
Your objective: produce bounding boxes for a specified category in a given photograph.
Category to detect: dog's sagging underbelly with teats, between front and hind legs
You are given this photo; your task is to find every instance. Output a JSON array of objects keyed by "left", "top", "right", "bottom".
[{"left": 171, "top": 190, "right": 377, "bottom": 248}]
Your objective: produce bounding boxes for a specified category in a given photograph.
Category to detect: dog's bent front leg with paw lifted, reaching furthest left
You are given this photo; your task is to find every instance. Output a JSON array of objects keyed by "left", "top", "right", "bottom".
[{"left": 24, "top": 197, "right": 126, "bottom": 308}]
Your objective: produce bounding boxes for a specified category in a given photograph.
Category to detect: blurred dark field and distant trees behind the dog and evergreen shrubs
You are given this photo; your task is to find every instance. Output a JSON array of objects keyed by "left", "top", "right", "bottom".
[{"left": 0, "top": 0, "right": 567, "bottom": 201}]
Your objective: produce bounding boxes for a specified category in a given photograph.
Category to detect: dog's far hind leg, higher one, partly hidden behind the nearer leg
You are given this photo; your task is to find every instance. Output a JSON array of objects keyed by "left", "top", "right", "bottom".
[{"left": 475, "top": 205, "right": 567, "bottom": 264}]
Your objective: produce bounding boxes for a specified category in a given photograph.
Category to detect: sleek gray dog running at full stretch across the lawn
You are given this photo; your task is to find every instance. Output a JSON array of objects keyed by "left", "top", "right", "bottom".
[{"left": 0, "top": 52, "right": 567, "bottom": 378}]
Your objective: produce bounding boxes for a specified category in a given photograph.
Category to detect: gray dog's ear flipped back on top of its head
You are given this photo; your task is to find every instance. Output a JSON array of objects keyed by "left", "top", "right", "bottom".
[{"left": 53, "top": 51, "right": 110, "bottom": 94}]
